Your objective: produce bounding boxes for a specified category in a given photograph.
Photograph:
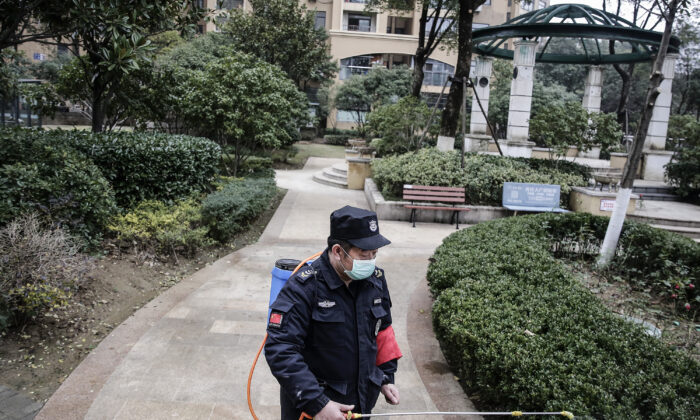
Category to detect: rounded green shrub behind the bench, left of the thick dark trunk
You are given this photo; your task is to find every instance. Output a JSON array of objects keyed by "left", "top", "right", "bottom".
[{"left": 367, "top": 96, "right": 439, "bottom": 156}]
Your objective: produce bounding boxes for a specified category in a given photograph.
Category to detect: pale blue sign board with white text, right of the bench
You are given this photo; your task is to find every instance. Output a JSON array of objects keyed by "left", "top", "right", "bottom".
[{"left": 502, "top": 182, "right": 569, "bottom": 215}]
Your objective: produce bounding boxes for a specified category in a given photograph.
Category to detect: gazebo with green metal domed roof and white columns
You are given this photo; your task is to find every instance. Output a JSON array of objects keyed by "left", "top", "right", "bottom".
[{"left": 465, "top": 4, "right": 680, "bottom": 176}]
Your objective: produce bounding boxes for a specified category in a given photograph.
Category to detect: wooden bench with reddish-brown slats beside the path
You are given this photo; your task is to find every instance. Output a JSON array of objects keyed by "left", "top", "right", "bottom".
[{"left": 403, "top": 185, "right": 471, "bottom": 229}]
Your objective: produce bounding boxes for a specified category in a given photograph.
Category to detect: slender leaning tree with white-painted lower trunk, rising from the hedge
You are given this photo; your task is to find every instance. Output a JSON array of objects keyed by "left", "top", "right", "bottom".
[{"left": 598, "top": 0, "right": 690, "bottom": 266}]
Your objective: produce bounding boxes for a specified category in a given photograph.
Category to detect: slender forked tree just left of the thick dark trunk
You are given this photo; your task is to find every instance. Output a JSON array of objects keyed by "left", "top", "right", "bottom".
[{"left": 367, "top": 0, "right": 459, "bottom": 98}]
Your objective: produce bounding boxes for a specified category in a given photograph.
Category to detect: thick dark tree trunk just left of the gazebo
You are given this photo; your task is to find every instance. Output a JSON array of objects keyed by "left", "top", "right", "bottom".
[{"left": 440, "top": 1, "right": 478, "bottom": 137}]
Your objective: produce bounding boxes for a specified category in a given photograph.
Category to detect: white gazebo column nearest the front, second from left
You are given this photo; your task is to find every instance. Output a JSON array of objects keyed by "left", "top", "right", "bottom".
[{"left": 506, "top": 40, "right": 537, "bottom": 141}]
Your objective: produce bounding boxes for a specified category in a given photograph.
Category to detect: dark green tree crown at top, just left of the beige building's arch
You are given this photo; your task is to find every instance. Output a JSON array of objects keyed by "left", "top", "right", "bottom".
[{"left": 224, "top": 0, "right": 338, "bottom": 90}]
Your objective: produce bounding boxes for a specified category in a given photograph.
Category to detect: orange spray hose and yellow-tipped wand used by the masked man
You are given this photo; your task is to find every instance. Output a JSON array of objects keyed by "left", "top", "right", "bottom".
[{"left": 246, "top": 251, "right": 574, "bottom": 420}]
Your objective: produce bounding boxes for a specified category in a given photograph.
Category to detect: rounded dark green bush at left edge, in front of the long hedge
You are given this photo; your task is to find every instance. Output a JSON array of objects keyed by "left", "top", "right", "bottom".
[{"left": 0, "top": 128, "right": 116, "bottom": 241}]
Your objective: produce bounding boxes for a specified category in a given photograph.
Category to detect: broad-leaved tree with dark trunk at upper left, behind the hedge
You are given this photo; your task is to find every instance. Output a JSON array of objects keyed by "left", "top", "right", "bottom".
[{"left": 53, "top": 0, "right": 205, "bottom": 132}]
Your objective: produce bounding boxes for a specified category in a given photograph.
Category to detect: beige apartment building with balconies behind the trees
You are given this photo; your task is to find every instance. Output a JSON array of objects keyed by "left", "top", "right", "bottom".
[{"left": 200, "top": 0, "right": 549, "bottom": 128}]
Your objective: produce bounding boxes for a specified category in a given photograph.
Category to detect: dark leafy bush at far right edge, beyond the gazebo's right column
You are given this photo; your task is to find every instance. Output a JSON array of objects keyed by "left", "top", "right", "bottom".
[{"left": 666, "top": 115, "right": 700, "bottom": 201}]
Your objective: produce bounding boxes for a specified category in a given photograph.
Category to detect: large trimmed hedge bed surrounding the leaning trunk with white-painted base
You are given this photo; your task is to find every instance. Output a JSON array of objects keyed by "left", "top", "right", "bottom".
[{"left": 428, "top": 214, "right": 700, "bottom": 419}]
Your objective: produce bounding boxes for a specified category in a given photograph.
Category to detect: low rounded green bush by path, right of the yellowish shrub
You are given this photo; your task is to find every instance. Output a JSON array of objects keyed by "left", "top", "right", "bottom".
[{"left": 202, "top": 178, "right": 277, "bottom": 242}]
